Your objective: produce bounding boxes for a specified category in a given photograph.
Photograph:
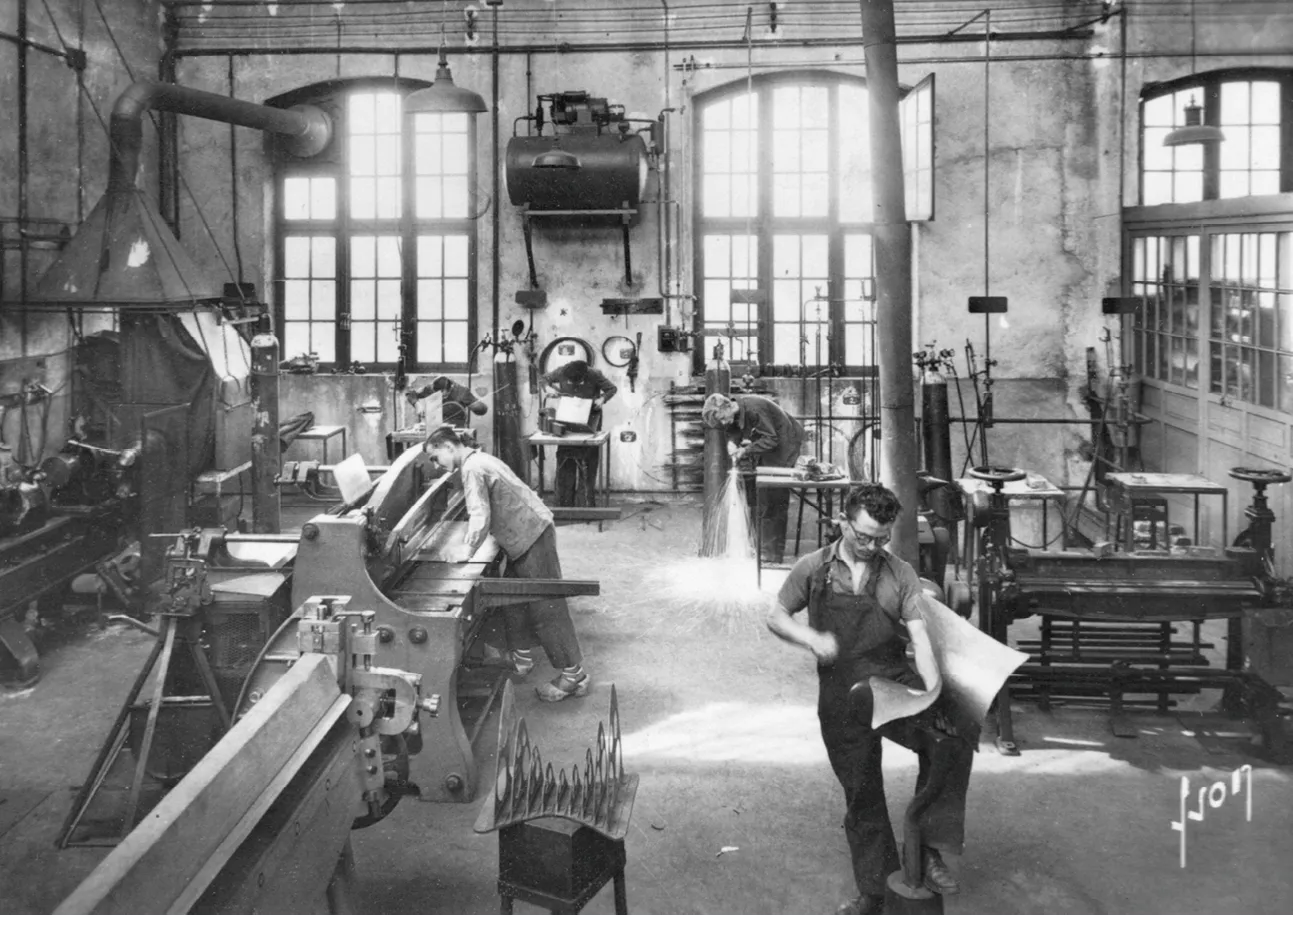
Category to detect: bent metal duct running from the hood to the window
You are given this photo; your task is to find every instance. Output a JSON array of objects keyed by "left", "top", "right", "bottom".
[{"left": 107, "top": 81, "right": 332, "bottom": 191}]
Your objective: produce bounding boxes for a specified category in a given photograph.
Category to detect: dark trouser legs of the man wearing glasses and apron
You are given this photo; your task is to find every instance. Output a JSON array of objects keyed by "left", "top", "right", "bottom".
[{"left": 821, "top": 698, "right": 975, "bottom": 894}]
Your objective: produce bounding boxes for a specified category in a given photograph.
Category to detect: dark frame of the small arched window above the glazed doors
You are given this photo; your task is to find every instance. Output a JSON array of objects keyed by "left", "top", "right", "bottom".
[{"left": 1137, "top": 67, "right": 1293, "bottom": 208}]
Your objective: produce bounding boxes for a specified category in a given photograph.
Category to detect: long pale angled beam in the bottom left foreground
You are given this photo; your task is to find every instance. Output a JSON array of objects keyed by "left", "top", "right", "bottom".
[{"left": 54, "top": 655, "right": 341, "bottom": 917}]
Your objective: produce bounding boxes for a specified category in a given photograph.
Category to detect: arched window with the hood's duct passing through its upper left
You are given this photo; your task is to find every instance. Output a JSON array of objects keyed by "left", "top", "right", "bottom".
[{"left": 269, "top": 78, "right": 476, "bottom": 371}]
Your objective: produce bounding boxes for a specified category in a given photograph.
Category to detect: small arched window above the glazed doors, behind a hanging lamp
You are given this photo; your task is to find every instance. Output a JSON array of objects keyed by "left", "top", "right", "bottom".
[{"left": 1140, "top": 68, "right": 1293, "bottom": 205}]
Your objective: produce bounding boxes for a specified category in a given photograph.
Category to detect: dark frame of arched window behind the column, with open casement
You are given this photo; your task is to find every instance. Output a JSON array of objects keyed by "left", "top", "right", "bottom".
[{"left": 692, "top": 68, "right": 936, "bottom": 376}]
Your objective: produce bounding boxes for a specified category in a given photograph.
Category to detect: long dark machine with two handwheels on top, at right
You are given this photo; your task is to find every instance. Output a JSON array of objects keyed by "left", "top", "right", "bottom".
[{"left": 968, "top": 468, "right": 1289, "bottom": 755}]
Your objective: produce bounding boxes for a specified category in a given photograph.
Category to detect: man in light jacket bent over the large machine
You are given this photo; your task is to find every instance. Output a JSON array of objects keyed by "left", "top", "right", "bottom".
[{"left": 425, "top": 424, "right": 591, "bottom": 703}]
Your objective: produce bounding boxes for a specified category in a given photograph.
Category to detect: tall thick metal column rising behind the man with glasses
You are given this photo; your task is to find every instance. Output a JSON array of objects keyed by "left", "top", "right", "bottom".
[{"left": 860, "top": 0, "right": 919, "bottom": 563}]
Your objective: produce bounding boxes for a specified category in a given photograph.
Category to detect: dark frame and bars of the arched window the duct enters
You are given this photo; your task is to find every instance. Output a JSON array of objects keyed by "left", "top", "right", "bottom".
[{"left": 265, "top": 76, "right": 480, "bottom": 373}]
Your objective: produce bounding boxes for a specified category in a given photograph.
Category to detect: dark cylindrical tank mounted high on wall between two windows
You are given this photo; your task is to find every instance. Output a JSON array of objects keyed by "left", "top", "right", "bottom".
[{"left": 506, "top": 133, "right": 648, "bottom": 211}]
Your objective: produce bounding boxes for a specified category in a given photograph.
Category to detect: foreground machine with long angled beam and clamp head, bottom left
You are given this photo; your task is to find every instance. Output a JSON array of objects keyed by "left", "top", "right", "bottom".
[{"left": 54, "top": 597, "right": 424, "bottom": 917}]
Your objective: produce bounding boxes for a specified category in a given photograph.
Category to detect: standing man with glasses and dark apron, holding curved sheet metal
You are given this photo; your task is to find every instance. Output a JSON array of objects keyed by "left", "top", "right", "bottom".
[{"left": 768, "top": 485, "right": 978, "bottom": 917}]
